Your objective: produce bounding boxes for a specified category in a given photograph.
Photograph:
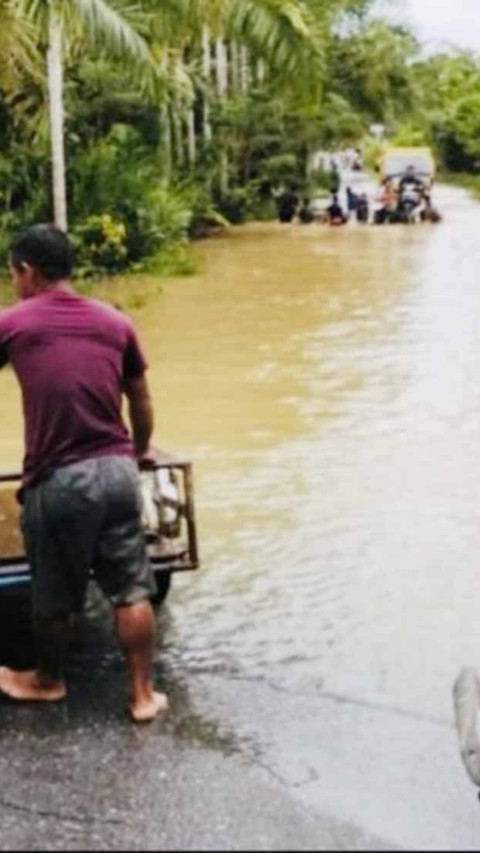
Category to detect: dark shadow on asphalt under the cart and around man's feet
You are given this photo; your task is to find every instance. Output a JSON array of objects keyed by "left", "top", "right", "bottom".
[{"left": 0, "top": 584, "right": 240, "bottom": 754}]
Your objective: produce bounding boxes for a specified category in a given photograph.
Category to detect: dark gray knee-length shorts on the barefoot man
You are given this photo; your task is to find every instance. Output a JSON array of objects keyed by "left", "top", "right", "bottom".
[{"left": 24, "top": 456, "right": 155, "bottom": 619}]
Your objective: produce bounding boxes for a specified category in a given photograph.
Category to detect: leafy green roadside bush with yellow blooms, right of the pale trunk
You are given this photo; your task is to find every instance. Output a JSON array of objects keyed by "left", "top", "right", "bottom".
[{"left": 68, "top": 125, "right": 198, "bottom": 274}]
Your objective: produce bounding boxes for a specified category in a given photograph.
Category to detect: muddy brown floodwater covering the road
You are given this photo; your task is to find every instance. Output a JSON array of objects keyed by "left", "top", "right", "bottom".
[{"left": 0, "top": 181, "right": 480, "bottom": 718}]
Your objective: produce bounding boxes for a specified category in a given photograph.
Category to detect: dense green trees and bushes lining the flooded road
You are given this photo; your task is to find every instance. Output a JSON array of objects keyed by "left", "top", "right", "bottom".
[{"left": 0, "top": 0, "right": 480, "bottom": 274}]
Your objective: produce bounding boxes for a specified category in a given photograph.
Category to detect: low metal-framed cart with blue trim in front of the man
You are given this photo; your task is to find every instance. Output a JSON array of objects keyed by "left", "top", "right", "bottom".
[{"left": 0, "top": 452, "right": 199, "bottom": 604}]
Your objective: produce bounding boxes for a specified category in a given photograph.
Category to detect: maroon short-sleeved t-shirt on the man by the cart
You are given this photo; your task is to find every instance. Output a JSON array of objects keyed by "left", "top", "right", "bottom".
[{"left": 0, "top": 287, "right": 147, "bottom": 487}]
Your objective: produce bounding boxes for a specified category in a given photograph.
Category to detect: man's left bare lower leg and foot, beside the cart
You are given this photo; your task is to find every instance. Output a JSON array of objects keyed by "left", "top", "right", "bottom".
[{"left": 0, "top": 616, "right": 73, "bottom": 702}]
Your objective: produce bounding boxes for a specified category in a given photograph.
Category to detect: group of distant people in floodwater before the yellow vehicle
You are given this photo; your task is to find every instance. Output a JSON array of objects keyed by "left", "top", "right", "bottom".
[{"left": 278, "top": 167, "right": 440, "bottom": 225}]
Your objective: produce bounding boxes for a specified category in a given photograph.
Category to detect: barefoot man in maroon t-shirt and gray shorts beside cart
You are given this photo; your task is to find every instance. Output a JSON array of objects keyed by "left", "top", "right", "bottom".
[{"left": 0, "top": 225, "right": 168, "bottom": 722}]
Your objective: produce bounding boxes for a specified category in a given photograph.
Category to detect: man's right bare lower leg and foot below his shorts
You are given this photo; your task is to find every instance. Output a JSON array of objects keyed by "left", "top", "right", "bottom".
[{"left": 115, "top": 601, "right": 168, "bottom": 723}]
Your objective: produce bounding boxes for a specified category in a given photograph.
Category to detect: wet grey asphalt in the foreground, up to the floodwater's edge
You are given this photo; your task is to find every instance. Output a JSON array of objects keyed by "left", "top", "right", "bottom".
[{"left": 0, "top": 576, "right": 480, "bottom": 850}]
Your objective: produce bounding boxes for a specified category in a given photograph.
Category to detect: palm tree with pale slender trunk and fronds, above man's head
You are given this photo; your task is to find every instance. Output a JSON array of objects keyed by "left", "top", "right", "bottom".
[{"left": 18, "top": 0, "right": 153, "bottom": 231}]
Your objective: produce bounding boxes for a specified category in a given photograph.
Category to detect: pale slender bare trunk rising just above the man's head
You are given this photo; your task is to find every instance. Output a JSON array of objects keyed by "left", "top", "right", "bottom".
[{"left": 47, "top": 11, "right": 68, "bottom": 231}]
